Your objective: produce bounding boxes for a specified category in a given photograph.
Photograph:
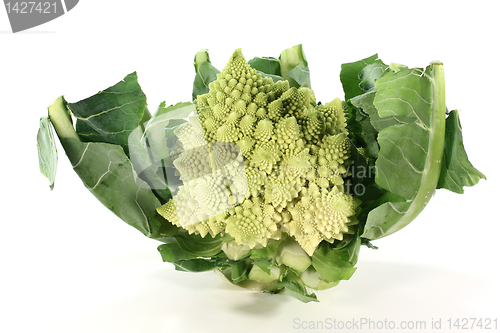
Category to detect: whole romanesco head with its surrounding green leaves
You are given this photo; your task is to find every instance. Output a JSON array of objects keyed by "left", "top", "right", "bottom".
[{"left": 41, "top": 45, "right": 485, "bottom": 302}]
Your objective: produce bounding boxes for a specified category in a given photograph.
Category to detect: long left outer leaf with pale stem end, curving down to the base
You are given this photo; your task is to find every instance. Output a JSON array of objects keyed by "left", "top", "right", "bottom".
[{"left": 49, "top": 97, "right": 163, "bottom": 238}]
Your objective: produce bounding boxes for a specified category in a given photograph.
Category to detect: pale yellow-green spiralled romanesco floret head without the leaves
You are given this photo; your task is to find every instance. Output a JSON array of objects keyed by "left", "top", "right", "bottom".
[{"left": 158, "top": 49, "right": 358, "bottom": 256}]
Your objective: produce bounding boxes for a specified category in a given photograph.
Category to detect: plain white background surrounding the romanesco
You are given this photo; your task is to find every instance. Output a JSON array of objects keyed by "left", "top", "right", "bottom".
[{"left": 0, "top": 0, "right": 500, "bottom": 333}]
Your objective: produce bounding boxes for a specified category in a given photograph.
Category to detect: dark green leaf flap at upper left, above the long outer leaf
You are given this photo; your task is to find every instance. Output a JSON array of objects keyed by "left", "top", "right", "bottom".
[{"left": 68, "top": 72, "right": 149, "bottom": 153}]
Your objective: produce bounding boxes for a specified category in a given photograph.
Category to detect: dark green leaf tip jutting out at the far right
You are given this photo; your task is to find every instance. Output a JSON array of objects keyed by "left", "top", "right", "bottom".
[{"left": 437, "top": 110, "right": 486, "bottom": 194}]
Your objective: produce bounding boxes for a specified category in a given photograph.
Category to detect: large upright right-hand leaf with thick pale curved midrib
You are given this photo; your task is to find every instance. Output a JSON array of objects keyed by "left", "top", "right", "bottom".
[{"left": 362, "top": 63, "right": 446, "bottom": 239}]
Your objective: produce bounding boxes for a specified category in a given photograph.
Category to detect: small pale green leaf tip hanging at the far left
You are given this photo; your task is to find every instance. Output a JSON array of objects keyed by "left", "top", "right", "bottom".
[{"left": 36, "top": 117, "right": 57, "bottom": 190}]
